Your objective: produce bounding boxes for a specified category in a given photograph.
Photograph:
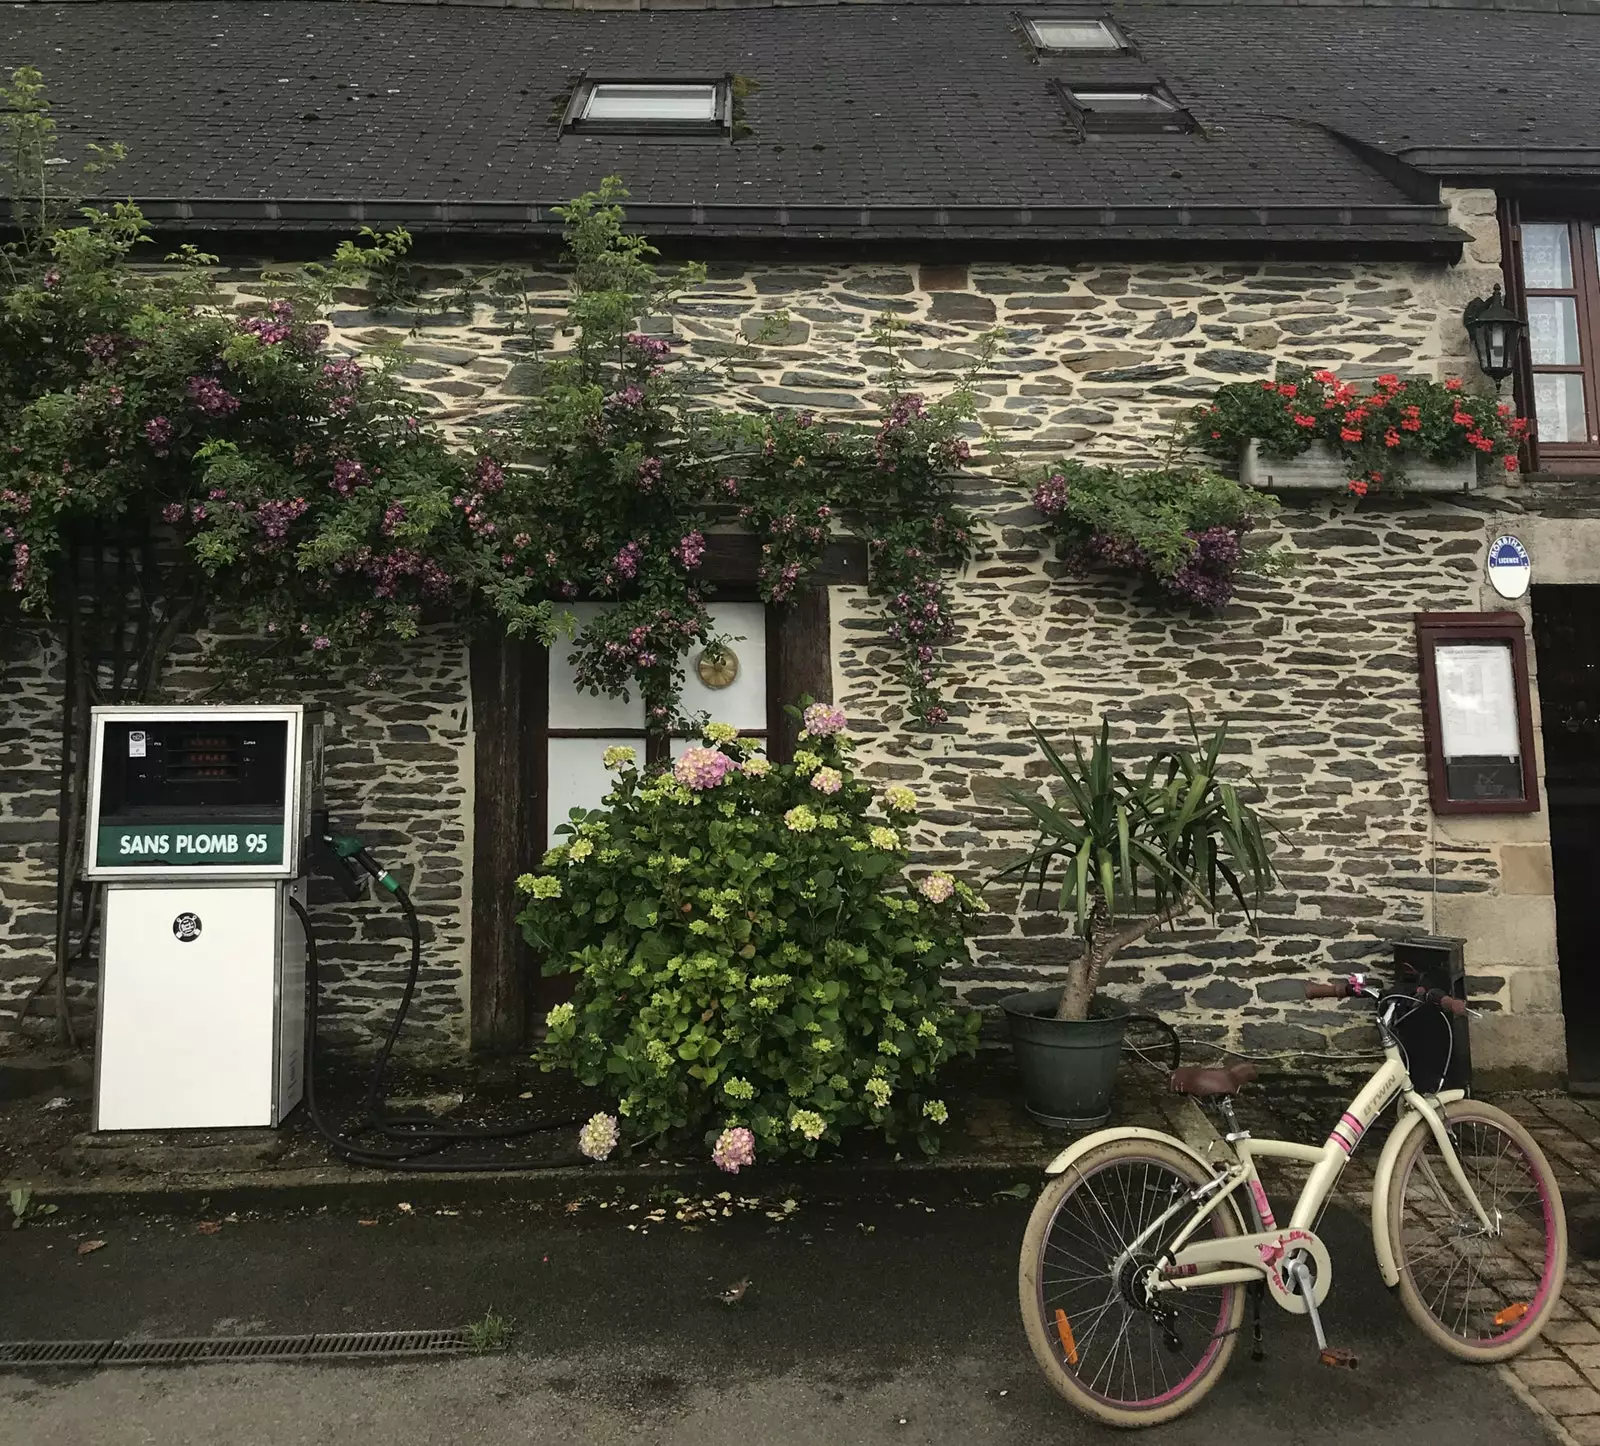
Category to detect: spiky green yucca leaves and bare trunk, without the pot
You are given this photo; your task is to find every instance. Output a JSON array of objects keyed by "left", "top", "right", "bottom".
[{"left": 1002, "top": 721, "right": 1277, "bottom": 1019}]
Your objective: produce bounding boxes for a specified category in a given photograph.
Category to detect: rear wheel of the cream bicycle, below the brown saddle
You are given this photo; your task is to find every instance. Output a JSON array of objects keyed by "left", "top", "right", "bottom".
[{"left": 1018, "top": 1139, "right": 1245, "bottom": 1427}]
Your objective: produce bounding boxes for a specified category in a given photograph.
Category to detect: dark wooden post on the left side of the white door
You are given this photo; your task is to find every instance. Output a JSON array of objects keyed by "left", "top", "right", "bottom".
[{"left": 470, "top": 638, "right": 547, "bottom": 1049}]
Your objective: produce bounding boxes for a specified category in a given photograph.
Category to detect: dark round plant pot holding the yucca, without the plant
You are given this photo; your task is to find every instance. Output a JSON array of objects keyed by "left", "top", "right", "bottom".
[{"left": 1000, "top": 989, "right": 1128, "bottom": 1131}]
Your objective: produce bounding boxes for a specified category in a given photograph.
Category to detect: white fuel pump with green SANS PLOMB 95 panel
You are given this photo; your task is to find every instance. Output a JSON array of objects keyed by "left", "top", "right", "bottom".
[{"left": 85, "top": 705, "right": 322, "bottom": 1131}]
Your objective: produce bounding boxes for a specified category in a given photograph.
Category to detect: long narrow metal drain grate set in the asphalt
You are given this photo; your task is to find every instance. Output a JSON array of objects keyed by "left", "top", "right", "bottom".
[{"left": 0, "top": 1331, "right": 467, "bottom": 1369}]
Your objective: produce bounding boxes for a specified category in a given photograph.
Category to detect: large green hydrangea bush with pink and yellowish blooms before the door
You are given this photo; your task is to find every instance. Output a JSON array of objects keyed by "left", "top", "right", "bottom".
[{"left": 518, "top": 704, "right": 979, "bottom": 1171}]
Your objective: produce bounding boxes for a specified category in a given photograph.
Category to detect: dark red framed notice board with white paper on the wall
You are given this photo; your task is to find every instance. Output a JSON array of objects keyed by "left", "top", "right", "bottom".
[{"left": 1416, "top": 613, "right": 1539, "bottom": 814}]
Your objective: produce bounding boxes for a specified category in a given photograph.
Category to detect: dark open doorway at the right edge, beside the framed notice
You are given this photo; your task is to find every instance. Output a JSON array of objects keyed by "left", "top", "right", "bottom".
[{"left": 1533, "top": 587, "right": 1600, "bottom": 1094}]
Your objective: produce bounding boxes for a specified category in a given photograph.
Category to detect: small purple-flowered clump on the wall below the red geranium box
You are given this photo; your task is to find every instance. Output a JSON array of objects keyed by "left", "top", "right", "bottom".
[{"left": 1034, "top": 462, "right": 1290, "bottom": 613}]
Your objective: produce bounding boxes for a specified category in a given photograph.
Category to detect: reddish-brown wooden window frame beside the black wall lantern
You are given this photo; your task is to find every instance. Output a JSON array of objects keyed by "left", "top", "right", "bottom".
[{"left": 1501, "top": 198, "right": 1600, "bottom": 473}]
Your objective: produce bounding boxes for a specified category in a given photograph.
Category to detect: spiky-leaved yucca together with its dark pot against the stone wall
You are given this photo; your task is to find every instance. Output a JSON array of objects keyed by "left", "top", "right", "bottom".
[{"left": 1000, "top": 721, "right": 1277, "bottom": 1128}]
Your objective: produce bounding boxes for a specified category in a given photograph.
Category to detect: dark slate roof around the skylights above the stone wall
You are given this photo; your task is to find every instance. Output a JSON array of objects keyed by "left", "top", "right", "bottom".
[{"left": 9, "top": 0, "right": 1600, "bottom": 254}]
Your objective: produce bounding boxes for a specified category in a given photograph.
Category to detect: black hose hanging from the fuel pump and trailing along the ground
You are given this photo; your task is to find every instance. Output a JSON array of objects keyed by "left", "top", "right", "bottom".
[{"left": 288, "top": 878, "right": 581, "bottom": 1172}]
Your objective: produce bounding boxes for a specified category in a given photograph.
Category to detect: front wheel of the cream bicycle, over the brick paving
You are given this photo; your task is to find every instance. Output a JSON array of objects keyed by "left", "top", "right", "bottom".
[{"left": 1389, "top": 1099, "right": 1566, "bottom": 1361}]
